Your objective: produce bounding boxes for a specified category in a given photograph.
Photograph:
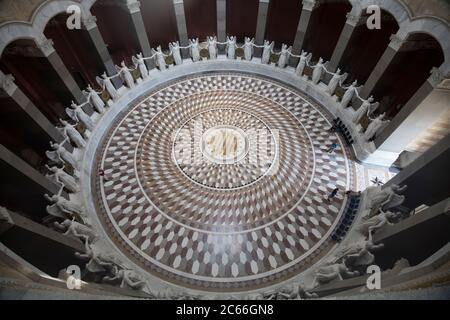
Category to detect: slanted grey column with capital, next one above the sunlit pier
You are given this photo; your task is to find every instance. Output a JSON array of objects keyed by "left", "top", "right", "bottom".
[{"left": 360, "top": 34, "right": 404, "bottom": 99}]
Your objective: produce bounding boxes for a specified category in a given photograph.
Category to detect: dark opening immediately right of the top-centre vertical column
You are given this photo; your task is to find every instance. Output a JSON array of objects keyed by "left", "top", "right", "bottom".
[{"left": 226, "top": 0, "right": 259, "bottom": 42}]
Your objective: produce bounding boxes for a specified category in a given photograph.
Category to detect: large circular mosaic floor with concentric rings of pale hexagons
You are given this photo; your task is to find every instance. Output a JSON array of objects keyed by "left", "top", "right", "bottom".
[{"left": 93, "top": 73, "right": 353, "bottom": 291}]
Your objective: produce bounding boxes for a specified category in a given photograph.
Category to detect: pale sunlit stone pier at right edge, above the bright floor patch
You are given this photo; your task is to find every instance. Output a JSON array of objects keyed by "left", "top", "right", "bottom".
[{"left": 375, "top": 68, "right": 450, "bottom": 161}]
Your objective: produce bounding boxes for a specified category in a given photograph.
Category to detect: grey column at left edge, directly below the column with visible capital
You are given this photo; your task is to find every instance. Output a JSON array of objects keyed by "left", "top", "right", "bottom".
[{"left": 0, "top": 144, "right": 59, "bottom": 194}]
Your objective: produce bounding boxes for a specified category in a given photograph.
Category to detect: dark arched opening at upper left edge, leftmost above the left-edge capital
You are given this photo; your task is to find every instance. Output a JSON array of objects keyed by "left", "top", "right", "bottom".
[{"left": 0, "top": 39, "right": 74, "bottom": 123}]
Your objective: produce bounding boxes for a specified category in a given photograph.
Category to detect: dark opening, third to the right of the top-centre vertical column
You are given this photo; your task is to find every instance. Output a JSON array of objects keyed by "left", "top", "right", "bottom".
[{"left": 303, "top": 0, "right": 352, "bottom": 61}]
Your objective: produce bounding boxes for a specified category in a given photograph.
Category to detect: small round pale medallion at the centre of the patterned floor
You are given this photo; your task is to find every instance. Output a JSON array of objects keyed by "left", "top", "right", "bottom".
[{"left": 200, "top": 125, "right": 249, "bottom": 164}]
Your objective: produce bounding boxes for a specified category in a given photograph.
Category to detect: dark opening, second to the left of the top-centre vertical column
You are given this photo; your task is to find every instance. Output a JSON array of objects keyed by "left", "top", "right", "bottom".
[{"left": 141, "top": 0, "right": 178, "bottom": 48}]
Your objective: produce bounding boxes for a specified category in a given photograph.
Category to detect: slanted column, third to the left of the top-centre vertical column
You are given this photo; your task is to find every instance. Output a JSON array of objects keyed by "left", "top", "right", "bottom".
[{"left": 83, "top": 15, "right": 122, "bottom": 88}]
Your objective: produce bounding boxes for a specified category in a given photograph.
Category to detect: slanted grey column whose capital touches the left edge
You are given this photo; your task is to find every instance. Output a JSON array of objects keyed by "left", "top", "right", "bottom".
[{"left": 0, "top": 71, "right": 64, "bottom": 142}]
